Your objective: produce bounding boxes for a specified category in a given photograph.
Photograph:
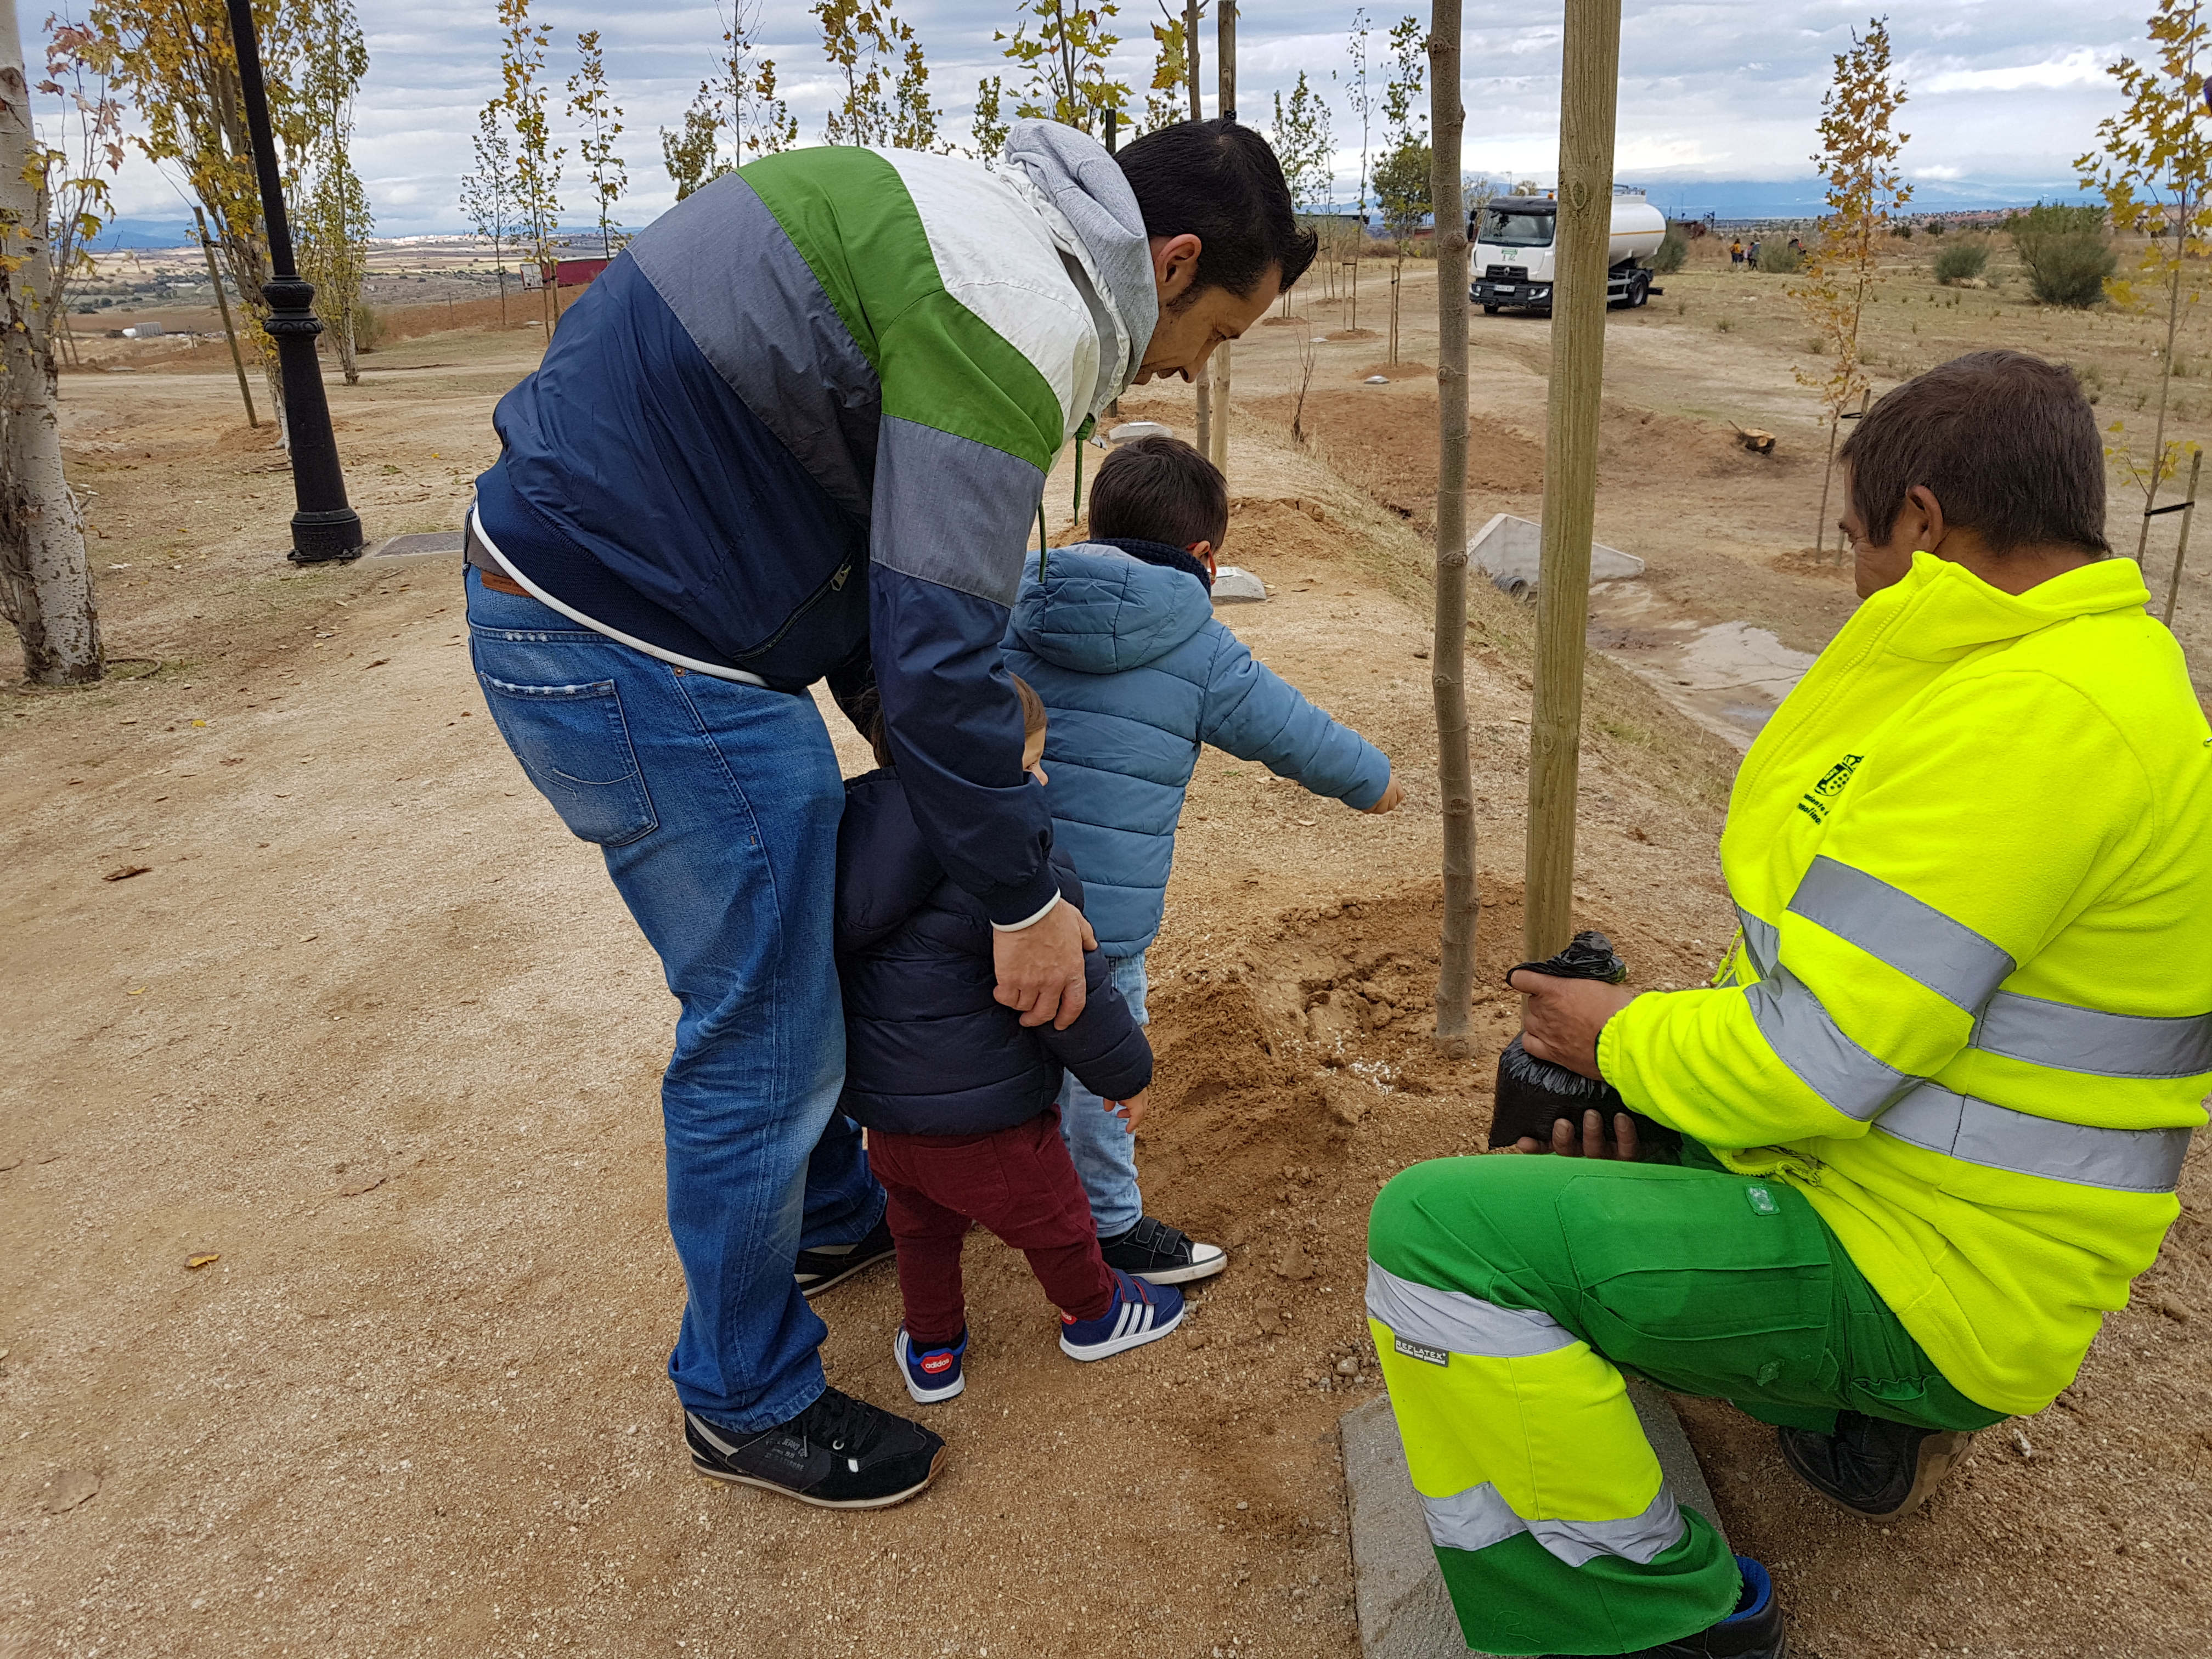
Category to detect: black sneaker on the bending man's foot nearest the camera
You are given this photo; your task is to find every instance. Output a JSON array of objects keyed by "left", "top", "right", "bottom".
[{"left": 684, "top": 1389, "right": 945, "bottom": 1509}]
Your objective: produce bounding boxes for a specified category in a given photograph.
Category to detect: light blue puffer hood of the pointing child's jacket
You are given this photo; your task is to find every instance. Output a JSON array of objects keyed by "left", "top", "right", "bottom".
[{"left": 1013, "top": 542, "right": 1215, "bottom": 675}]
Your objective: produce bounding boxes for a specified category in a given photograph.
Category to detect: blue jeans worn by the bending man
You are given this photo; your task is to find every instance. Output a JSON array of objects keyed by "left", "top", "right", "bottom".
[{"left": 467, "top": 568, "right": 883, "bottom": 1429}]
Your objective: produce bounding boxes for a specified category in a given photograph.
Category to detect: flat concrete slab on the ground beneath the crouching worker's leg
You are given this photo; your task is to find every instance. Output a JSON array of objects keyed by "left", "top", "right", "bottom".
[{"left": 1336, "top": 1383, "right": 1721, "bottom": 1659}]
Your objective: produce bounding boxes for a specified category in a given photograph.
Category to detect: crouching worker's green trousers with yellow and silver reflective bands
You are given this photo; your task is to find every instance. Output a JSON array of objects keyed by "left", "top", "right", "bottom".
[{"left": 1367, "top": 1144, "right": 2004, "bottom": 1655}]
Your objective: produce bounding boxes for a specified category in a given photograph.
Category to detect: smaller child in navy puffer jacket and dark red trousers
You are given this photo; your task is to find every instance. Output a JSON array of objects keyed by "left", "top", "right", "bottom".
[{"left": 836, "top": 679, "right": 1183, "bottom": 1404}]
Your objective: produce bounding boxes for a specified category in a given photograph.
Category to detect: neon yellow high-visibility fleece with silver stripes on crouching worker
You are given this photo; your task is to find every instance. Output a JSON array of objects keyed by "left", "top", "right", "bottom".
[{"left": 1597, "top": 553, "right": 2212, "bottom": 1413}]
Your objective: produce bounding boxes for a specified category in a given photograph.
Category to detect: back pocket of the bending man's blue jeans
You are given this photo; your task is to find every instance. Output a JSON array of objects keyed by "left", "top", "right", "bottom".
[{"left": 478, "top": 673, "right": 659, "bottom": 847}]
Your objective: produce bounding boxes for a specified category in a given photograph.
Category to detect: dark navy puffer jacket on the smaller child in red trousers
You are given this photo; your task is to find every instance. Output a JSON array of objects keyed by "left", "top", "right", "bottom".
[{"left": 836, "top": 770, "right": 1153, "bottom": 1135}]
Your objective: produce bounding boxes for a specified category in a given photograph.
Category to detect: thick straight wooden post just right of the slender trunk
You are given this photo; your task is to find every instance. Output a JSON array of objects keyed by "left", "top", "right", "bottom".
[{"left": 1522, "top": 0, "right": 1621, "bottom": 960}]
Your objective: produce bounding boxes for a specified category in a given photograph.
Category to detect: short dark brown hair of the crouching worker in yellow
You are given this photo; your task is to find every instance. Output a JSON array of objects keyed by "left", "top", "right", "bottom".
[{"left": 1838, "top": 352, "right": 2113, "bottom": 553}]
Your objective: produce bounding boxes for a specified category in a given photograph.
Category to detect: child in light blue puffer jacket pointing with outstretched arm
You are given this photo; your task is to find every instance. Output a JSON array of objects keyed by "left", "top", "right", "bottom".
[{"left": 1005, "top": 436, "right": 1398, "bottom": 1285}]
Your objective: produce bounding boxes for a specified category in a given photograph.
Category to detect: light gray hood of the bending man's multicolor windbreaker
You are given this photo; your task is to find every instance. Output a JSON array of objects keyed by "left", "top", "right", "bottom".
[{"left": 1005, "top": 122, "right": 1159, "bottom": 407}]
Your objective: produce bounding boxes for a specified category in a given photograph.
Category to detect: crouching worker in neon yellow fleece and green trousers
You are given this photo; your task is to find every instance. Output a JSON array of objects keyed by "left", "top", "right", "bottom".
[{"left": 1367, "top": 352, "right": 2212, "bottom": 1659}]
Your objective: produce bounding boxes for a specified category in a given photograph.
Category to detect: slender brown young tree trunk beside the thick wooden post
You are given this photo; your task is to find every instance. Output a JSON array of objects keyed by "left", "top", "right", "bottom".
[{"left": 1429, "top": 0, "right": 1477, "bottom": 1057}]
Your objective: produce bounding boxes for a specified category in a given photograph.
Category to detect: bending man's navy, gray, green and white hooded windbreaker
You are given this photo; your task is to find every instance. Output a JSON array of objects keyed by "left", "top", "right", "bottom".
[{"left": 473, "top": 122, "right": 1159, "bottom": 922}]
